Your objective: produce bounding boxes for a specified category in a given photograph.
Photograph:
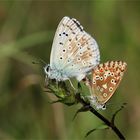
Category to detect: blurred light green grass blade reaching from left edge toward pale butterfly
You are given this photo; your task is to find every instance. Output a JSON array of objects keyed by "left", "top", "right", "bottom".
[{"left": 0, "top": 31, "right": 52, "bottom": 58}]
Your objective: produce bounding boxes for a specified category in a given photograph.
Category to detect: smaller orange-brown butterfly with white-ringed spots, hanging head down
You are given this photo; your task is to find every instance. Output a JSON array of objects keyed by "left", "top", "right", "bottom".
[{"left": 86, "top": 61, "right": 127, "bottom": 109}]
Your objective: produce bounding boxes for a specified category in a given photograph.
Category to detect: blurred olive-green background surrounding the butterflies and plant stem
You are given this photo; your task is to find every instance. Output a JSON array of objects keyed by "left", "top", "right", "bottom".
[{"left": 0, "top": 0, "right": 140, "bottom": 140}]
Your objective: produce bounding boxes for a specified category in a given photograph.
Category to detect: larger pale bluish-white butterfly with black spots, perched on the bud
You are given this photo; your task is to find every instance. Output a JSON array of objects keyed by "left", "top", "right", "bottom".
[{"left": 44, "top": 17, "right": 100, "bottom": 81}]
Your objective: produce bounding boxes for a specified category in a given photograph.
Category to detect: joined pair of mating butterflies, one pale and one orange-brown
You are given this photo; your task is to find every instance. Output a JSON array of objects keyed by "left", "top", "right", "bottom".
[{"left": 44, "top": 17, "right": 126, "bottom": 108}]
